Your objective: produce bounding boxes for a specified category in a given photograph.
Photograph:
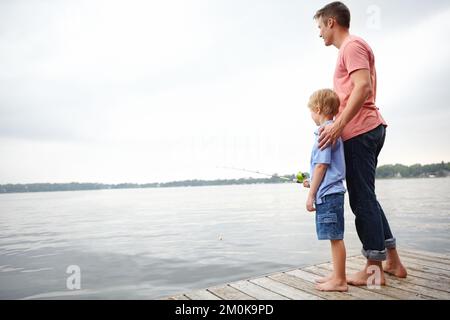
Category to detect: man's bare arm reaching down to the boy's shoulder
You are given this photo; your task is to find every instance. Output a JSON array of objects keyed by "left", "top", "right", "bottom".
[{"left": 319, "top": 69, "right": 373, "bottom": 150}]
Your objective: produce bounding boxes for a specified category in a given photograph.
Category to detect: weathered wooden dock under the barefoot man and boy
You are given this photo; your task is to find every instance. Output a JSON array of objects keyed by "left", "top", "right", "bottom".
[{"left": 166, "top": 250, "right": 450, "bottom": 300}]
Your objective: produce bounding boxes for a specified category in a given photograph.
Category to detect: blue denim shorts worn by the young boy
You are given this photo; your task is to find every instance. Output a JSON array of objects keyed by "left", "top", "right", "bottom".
[{"left": 316, "top": 193, "right": 344, "bottom": 240}]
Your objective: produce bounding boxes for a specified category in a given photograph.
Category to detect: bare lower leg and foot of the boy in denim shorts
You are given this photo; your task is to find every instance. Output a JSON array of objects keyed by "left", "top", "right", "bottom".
[{"left": 316, "top": 240, "right": 348, "bottom": 291}]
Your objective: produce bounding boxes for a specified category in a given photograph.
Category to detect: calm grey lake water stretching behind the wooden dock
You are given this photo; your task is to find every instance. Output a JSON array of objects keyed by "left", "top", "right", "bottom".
[{"left": 0, "top": 178, "right": 450, "bottom": 299}]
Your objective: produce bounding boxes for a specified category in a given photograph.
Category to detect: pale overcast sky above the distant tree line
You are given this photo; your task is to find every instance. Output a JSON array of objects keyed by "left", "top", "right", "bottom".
[{"left": 0, "top": 0, "right": 450, "bottom": 184}]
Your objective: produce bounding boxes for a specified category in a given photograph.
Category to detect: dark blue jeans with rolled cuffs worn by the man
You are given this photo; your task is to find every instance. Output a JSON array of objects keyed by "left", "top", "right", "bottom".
[{"left": 344, "top": 125, "right": 396, "bottom": 261}]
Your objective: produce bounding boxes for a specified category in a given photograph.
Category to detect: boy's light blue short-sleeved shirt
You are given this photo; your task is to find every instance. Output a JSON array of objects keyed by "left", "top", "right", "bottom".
[{"left": 310, "top": 120, "right": 345, "bottom": 204}]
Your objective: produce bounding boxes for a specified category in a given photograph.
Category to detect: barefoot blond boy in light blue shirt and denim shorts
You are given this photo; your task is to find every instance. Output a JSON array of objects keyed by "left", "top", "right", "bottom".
[{"left": 303, "top": 89, "right": 348, "bottom": 291}]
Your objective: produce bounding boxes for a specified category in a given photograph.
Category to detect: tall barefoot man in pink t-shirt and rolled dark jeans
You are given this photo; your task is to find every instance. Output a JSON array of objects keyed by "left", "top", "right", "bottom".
[{"left": 314, "top": 2, "right": 407, "bottom": 285}]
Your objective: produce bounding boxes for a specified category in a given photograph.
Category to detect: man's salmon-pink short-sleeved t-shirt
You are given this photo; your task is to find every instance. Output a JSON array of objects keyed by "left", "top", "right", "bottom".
[{"left": 334, "top": 35, "right": 386, "bottom": 141}]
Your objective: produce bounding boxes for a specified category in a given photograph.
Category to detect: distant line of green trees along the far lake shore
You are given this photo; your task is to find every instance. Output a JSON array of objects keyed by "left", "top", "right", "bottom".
[{"left": 0, "top": 162, "right": 450, "bottom": 193}]
